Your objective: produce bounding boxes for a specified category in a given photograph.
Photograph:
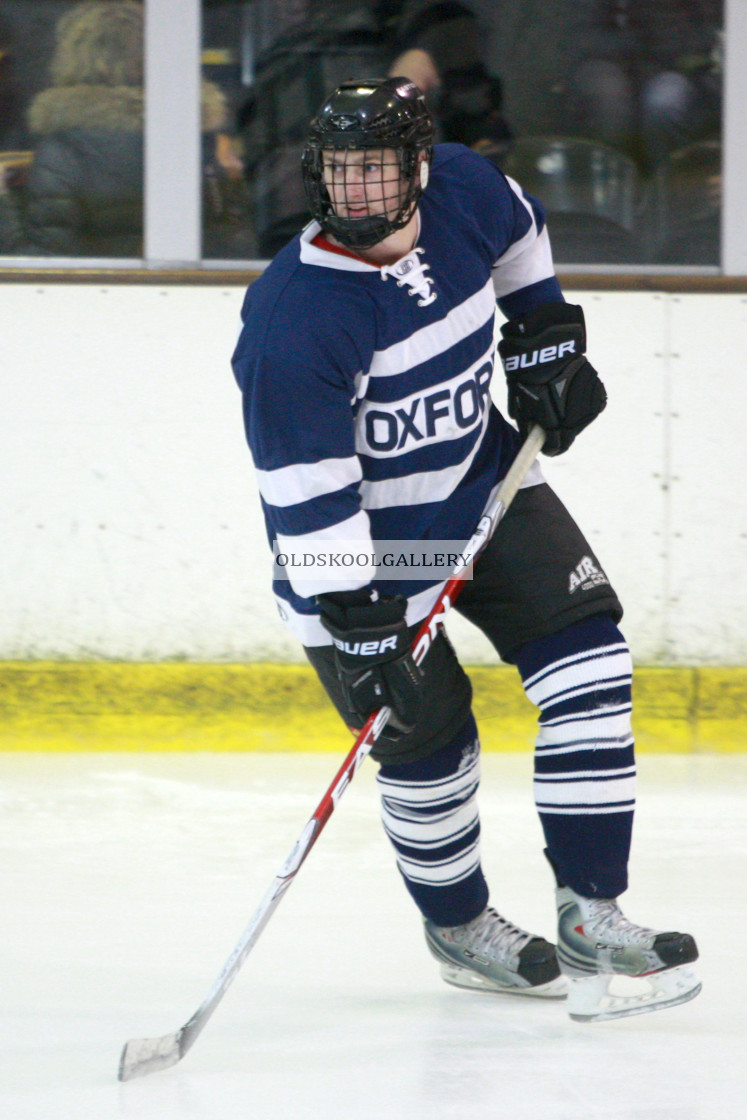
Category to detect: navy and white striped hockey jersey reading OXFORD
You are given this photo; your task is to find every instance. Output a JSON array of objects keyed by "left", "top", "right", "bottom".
[{"left": 233, "top": 144, "right": 562, "bottom": 645}]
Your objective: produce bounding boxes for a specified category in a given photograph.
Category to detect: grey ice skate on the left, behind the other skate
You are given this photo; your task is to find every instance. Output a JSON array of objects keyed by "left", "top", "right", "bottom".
[{"left": 426, "top": 907, "right": 568, "bottom": 999}]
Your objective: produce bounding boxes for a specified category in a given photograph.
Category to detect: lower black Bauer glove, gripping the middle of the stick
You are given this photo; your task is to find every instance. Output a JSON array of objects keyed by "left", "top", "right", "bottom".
[{"left": 317, "top": 588, "right": 423, "bottom": 732}]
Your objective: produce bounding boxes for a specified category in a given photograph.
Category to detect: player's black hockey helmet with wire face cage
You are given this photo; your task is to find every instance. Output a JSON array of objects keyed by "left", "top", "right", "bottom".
[{"left": 301, "top": 78, "right": 433, "bottom": 249}]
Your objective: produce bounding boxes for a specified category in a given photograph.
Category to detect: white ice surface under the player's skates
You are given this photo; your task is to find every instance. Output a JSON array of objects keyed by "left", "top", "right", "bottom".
[{"left": 0, "top": 745, "right": 747, "bottom": 1120}]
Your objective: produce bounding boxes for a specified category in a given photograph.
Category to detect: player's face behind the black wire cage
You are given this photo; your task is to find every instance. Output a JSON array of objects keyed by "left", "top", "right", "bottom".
[{"left": 324, "top": 148, "right": 405, "bottom": 220}]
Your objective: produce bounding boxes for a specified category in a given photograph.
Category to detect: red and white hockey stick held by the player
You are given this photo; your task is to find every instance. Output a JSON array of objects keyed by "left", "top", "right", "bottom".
[{"left": 119, "top": 426, "right": 544, "bottom": 1081}]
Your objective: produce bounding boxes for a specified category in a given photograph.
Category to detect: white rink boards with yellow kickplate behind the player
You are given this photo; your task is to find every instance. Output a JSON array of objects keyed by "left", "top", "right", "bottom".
[{"left": 0, "top": 284, "right": 747, "bottom": 753}]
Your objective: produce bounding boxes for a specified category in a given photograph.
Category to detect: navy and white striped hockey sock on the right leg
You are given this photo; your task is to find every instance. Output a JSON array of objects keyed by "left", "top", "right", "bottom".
[{"left": 516, "top": 615, "right": 635, "bottom": 898}]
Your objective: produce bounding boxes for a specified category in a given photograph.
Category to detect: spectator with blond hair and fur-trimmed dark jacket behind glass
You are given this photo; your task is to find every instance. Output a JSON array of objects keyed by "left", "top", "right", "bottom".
[{"left": 0, "top": 0, "right": 226, "bottom": 258}]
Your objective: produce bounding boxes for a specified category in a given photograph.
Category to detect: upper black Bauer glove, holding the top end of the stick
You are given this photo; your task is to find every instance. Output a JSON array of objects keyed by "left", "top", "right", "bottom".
[{"left": 498, "top": 302, "right": 607, "bottom": 455}]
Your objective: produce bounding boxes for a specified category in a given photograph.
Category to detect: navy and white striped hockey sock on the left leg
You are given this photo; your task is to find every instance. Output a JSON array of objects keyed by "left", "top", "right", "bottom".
[{"left": 377, "top": 715, "right": 487, "bottom": 925}]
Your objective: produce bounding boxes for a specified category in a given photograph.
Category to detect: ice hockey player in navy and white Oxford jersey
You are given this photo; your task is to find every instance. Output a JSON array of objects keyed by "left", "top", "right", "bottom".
[{"left": 233, "top": 78, "right": 700, "bottom": 1019}]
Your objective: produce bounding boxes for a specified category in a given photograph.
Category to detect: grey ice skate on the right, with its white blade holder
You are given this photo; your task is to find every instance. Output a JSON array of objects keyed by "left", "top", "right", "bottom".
[{"left": 555, "top": 887, "right": 701, "bottom": 1023}]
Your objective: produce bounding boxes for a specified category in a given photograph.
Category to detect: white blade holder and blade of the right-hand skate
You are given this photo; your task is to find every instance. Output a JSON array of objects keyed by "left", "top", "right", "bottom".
[{"left": 568, "top": 964, "right": 702, "bottom": 1023}]
